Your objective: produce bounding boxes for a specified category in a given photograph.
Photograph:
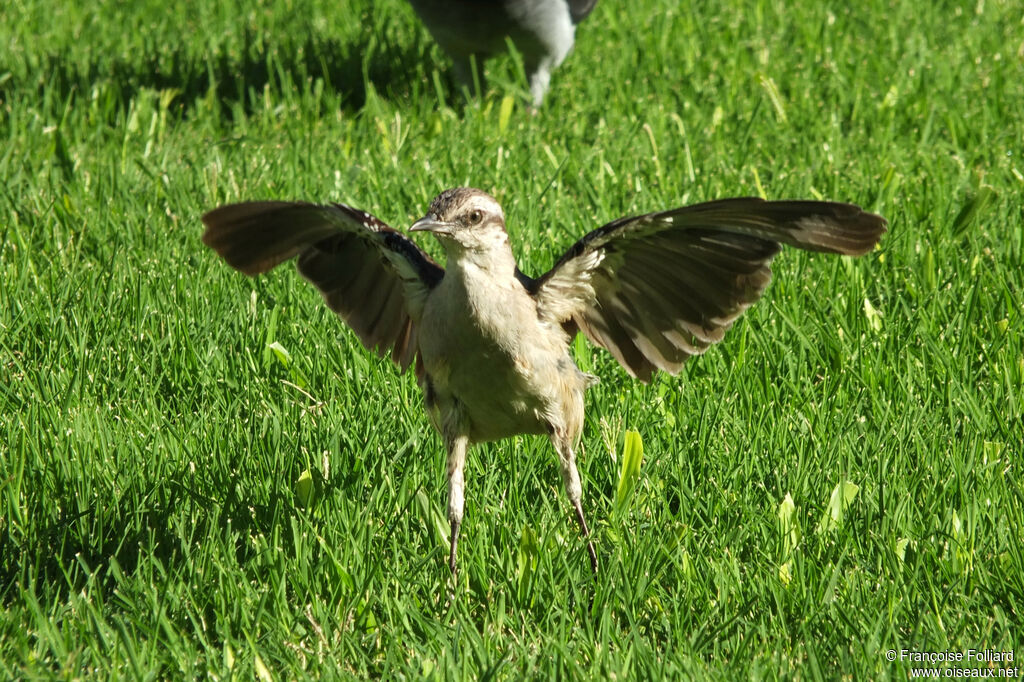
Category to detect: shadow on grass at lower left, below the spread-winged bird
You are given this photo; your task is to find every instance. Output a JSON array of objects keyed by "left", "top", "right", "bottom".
[{"left": 0, "top": 444, "right": 358, "bottom": 607}]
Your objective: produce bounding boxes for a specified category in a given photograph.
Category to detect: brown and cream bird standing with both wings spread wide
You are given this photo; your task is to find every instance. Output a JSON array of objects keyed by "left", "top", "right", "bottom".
[{"left": 202, "top": 187, "right": 888, "bottom": 574}]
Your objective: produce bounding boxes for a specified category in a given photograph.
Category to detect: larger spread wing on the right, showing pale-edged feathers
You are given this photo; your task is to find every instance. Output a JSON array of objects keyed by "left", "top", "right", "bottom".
[{"left": 523, "top": 199, "right": 886, "bottom": 381}]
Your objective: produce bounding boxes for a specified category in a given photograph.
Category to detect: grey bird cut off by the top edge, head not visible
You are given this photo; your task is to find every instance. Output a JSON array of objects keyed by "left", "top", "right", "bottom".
[{"left": 410, "top": 0, "right": 597, "bottom": 106}]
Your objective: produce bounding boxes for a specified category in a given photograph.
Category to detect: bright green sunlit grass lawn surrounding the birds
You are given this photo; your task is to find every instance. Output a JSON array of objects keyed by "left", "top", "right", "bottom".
[{"left": 0, "top": 0, "right": 1024, "bottom": 680}]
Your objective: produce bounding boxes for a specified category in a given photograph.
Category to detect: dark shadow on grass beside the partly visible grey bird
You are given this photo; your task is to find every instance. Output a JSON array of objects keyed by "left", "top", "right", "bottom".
[{"left": 8, "top": 28, "right": 455, "bottom": 123}]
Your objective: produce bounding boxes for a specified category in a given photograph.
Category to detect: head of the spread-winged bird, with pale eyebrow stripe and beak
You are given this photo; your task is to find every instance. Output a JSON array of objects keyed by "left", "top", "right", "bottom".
[{"left": 410, "top": 187, "right": 509, "bottom": 258}]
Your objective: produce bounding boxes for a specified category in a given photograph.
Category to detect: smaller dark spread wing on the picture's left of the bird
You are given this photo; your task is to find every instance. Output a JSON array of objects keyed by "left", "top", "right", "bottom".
[{"left": 203, "top": 202, "right": 444, "bottom": 371}]
